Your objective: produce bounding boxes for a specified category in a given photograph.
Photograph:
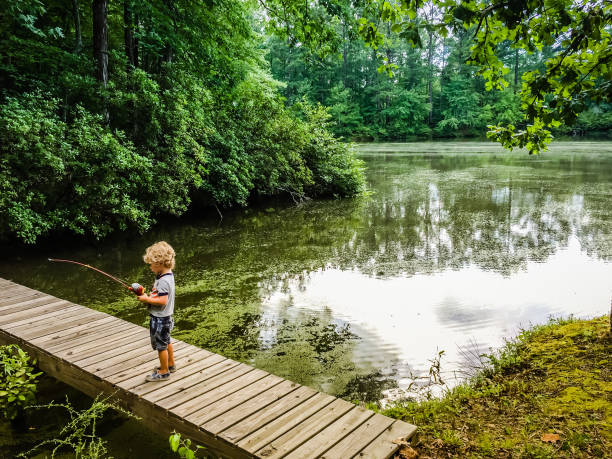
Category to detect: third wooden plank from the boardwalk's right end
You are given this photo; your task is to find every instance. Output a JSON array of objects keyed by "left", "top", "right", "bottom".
[{"left": 285, "top": 406, "right": 374, "bottom": 459}]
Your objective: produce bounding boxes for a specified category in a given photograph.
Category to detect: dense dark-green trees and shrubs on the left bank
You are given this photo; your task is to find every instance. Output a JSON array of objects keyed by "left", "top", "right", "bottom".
[{"left": 0, "top": 0, "right": 363, "bottom": 243}]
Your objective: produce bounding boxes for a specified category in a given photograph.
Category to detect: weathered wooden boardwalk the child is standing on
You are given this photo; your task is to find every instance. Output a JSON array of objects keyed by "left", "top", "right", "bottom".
[{"left": 0, "top": 278, "right": 416, "bottom": 459}]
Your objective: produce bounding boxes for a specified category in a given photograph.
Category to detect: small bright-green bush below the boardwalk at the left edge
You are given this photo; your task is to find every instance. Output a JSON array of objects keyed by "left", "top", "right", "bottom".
[{"left": 0, "top": 344, "right": 41, "bottom": 419}]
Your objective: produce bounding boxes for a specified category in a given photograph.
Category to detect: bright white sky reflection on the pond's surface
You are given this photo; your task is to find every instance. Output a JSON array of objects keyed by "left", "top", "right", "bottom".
[{"left": 264, "top": 238, "right": 612, "bottom": 398}]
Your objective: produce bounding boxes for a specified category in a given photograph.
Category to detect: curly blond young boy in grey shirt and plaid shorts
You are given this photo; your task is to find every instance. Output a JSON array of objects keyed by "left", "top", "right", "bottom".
[{"left": 138, "top": 241, "right": 176, "bottom": 381}]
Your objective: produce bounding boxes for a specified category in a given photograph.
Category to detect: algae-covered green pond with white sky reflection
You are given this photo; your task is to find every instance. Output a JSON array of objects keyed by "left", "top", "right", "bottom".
[{"left": 0, "top": 142, "right": 612, "bottom": 456}]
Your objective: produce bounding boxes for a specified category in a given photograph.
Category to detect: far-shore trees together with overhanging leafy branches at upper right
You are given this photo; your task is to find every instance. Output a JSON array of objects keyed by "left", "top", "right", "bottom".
[{"left": 265, "top": 0, "right": 612, "bottom": 147}]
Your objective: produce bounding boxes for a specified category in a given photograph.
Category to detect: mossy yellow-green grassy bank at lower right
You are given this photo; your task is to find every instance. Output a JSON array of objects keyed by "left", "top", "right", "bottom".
[{"left": 383, "top": 316, "right": 612, "bottom": 458}]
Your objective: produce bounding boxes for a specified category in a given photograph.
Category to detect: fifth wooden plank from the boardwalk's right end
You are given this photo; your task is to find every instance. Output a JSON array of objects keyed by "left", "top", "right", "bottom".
[{"left": 237, "top": 393, "right": 344, "bottom": 454}]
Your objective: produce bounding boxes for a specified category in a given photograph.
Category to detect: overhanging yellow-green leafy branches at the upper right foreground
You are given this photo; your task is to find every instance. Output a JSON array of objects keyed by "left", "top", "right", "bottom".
[{"left": 261, "top": 0, "right": 612, "bottom": 153}]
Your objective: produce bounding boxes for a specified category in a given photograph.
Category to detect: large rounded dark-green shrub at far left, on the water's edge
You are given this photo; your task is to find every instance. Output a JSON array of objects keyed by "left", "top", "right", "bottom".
[{"left": 0, "top": 93, "right": 153, "bottom": 243}]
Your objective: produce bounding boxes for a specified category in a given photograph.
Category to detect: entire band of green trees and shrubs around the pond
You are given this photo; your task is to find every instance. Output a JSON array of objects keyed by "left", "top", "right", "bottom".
[{"left": 0, "top": 0, "right": 612, "bottom": 243}]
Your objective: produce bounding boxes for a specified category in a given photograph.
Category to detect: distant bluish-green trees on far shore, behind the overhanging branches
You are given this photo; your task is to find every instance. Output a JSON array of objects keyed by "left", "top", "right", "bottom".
[{"left": 267, "top": 20, "right": 612, "bottom": 141}]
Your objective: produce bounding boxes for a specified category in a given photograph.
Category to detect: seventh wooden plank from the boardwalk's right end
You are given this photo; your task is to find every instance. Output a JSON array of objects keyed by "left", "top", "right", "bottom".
[{"left": 200, "top": 381, "right": 300, "bottom": 435}]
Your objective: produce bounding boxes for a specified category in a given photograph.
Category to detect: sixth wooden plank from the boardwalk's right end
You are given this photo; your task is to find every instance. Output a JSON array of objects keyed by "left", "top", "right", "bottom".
[{"left": 219, "top": 386, "right": 318, "bottom": 443}]
